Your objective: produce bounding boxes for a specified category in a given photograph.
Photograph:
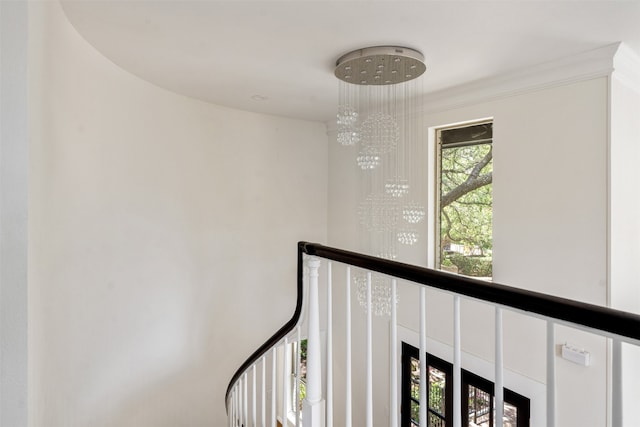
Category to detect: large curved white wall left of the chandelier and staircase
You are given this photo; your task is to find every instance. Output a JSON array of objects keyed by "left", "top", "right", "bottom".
[{"left": 28, "top": 2, "right": 327, "bottom": 427}]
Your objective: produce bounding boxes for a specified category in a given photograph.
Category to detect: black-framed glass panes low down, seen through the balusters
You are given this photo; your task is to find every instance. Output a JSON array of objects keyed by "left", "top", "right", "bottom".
[{"left": 401, "top": 343, "right": 530, "bottom": 427}]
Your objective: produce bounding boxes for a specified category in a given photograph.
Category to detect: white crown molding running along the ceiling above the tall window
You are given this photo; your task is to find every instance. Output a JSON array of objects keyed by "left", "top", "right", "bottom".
[{"left": 424, "top": 43, "right": 632, "bottom": 112}]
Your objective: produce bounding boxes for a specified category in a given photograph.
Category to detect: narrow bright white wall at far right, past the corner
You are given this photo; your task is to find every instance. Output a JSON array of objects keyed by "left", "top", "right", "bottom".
[{"left": 609, "top": 46, "right": 640, "bottom": 426}]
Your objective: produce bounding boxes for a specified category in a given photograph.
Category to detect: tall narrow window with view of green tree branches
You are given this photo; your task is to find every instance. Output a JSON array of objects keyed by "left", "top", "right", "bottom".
[{"left": 435, "top": 122, "right": 493, "bottom": 279}]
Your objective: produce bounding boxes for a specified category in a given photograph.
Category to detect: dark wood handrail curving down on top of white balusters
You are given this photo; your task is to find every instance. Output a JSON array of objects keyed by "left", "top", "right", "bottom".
[{"left": 225, "top": 242, "right": 640, "bottom": 412}]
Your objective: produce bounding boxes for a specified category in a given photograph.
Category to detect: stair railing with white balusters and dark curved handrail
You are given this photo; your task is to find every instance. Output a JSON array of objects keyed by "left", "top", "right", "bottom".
[{"left": 225, "top": 242, "right": 640, "bottom": 427}]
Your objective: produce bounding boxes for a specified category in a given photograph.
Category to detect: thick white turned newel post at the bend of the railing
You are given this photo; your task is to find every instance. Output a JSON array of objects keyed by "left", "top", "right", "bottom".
[{"left": 302, "top": 257, "right": 324, "bottom": 427}]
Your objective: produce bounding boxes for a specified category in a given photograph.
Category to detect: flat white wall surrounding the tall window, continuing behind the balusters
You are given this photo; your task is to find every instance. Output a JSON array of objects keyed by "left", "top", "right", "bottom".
[{"left": 329, "top": 77, "right": 609, "bottom": 427}]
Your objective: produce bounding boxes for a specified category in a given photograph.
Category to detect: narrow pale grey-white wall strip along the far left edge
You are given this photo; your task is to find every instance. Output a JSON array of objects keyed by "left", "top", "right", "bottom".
[{"left": 0, "top": 1, "right": 28, "bottom": 427}]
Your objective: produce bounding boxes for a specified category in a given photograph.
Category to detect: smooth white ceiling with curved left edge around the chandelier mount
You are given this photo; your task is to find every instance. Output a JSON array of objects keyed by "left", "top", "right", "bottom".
[{"left": 63, "top": 0, "right": 640, "bottom": 121}]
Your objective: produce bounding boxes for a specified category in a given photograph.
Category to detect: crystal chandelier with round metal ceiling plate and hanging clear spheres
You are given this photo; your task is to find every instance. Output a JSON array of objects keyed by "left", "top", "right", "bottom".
[{"left": 335, "top": 46, "right": 427, "bottom": 315}]
